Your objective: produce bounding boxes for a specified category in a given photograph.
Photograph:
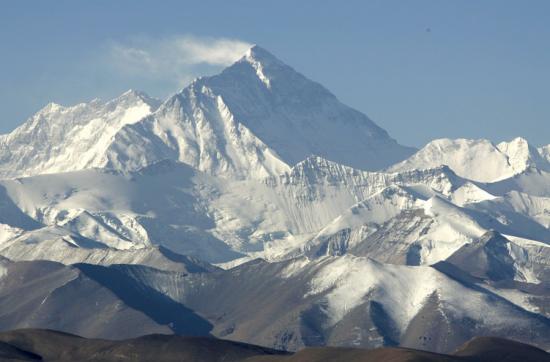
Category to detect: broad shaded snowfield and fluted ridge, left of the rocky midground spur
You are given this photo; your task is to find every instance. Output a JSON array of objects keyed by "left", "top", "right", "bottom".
[{"left": 0, "top": 158, "right": 462, "bottom": 262}]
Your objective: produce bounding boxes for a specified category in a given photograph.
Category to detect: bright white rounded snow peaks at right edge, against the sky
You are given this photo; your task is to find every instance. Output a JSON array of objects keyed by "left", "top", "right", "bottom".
[{"left": 389, "top": 137, "right": 550, "bottom": 182}]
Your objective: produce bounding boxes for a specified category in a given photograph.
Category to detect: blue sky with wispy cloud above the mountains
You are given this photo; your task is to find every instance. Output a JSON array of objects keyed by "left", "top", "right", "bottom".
[{"left": 0, "top": 0, "right": 550, "bottom": 146}]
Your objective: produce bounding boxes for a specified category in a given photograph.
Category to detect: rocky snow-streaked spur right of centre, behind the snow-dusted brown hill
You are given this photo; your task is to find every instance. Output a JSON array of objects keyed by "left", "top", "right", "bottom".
[{"left": 305, "top": 185, "right": 492, "bottom": 265}]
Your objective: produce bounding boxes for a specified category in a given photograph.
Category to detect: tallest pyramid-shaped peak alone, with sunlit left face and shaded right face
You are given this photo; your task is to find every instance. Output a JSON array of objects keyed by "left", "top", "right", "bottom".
[{"left": 103, "top": 46, "right": 413, "bottom": 178}]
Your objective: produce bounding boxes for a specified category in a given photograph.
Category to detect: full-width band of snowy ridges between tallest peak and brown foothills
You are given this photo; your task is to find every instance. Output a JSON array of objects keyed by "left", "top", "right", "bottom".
[{"left": 0, "top": 147, "right": 550, "bottom": 264}]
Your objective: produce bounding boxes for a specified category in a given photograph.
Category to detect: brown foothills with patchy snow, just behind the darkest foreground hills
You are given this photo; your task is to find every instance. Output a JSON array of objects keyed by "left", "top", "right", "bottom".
[{"left": 0, "top": 255, "right": 550, "bottom": 352}]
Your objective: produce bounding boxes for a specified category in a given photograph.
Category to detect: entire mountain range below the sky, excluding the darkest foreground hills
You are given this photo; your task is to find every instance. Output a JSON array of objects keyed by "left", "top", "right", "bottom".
[{"left": 0, "top": 46, "right": 550, "bottom": 354}]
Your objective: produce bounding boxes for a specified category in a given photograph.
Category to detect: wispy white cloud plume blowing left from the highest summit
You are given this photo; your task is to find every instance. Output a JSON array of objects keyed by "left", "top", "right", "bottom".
[{"left": 106, "top": 35, "right": 252, "bottom": 85}]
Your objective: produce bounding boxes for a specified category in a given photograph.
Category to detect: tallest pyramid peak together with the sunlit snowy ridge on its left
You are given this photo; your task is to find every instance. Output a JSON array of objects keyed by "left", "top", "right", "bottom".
[{"left": 0, "top": 46, "right": 414, "bottom": 178}]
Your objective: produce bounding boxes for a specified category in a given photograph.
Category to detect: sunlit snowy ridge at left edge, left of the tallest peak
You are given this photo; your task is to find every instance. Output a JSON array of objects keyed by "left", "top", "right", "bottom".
[{"left": 0, "top": 91, "right": 159, "bottom": 178}]
